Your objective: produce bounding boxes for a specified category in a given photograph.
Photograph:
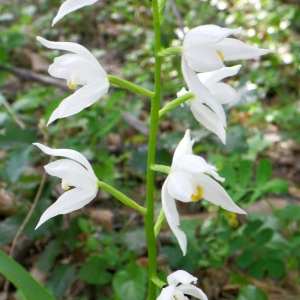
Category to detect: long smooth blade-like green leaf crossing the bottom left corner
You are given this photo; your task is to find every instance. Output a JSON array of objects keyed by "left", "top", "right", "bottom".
[{"left": 0, "top": 250, "right": 55, "bottom": 300}]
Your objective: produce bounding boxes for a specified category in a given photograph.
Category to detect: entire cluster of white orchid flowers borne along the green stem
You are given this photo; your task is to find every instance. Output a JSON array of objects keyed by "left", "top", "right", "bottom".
[{"left": 34, "top": 0, "right": 269, "bottom": 300}]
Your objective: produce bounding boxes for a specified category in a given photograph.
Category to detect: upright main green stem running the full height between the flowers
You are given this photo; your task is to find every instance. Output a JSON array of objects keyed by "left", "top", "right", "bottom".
[{"left": 145, "top": 0, "right": 161, "bottom": 300}]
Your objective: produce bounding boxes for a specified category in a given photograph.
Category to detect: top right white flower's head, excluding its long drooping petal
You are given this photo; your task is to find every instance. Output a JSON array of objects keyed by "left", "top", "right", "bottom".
[{"left": 182, "top": 25, "right": 270, "bottom": 72}]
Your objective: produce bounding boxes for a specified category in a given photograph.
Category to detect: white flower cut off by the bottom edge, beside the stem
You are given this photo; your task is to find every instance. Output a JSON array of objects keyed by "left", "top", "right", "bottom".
[{"left": 156, "top": 270, "right": 208, "bottom": 300}]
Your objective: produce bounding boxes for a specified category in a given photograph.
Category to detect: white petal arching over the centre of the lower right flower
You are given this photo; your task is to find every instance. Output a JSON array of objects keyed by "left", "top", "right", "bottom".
[{"left": 172, "top": 154, "right": 215, "bottom": 173}]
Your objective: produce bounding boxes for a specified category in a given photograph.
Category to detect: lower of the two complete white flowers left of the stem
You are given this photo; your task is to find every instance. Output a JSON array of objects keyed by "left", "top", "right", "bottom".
[{"left": 34, "top": 143, "right": 98, "bottom": 228}]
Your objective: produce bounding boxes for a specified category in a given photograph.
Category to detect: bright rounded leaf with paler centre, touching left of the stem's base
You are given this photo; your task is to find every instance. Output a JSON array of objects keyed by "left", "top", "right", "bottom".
[{"left": 112, "top": 263, "right": 147, "bottom": 300}]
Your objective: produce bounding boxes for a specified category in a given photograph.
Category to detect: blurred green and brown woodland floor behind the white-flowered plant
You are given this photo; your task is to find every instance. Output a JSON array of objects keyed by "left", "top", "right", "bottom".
[{"left": 0, "top": 0, "right": 300, "bottom": 300}]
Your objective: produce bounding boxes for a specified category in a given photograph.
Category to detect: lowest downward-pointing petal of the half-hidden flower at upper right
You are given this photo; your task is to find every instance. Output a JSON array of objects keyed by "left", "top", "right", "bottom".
[{"left": 191, "top": 99, "right": 226, "bottom": 144}]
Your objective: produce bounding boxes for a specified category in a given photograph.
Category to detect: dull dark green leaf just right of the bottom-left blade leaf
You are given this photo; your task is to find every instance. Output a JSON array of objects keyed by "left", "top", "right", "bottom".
[{"left": 47, "top": 264, "right": 76, "bottom": 298}]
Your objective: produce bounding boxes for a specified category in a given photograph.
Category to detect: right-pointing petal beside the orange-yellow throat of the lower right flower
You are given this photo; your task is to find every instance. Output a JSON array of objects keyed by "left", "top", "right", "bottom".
[{"left": 195, "top": 174, "right": 246, "bottom": 214}]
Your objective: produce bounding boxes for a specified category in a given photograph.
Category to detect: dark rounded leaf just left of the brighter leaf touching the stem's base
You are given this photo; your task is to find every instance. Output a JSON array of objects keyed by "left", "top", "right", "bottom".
[{"left": 78, "top": 255, "right": 111, "bottom": 285}]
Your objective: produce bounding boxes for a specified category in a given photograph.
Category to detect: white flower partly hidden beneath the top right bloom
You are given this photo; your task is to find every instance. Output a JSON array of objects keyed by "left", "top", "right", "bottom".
[{"left": 177, "top": 65, "right": 241, "bottom": 144}]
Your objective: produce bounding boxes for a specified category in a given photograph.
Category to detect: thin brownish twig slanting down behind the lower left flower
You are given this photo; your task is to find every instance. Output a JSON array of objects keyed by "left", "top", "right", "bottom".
[{"left": 3, "top": 156, "right": 53, "bottom": 292}]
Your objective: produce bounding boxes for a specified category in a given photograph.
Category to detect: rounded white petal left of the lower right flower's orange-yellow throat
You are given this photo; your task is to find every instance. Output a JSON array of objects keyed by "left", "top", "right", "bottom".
[{"left": 168, "top": 171, "right": 194, "bottom": 202}]
